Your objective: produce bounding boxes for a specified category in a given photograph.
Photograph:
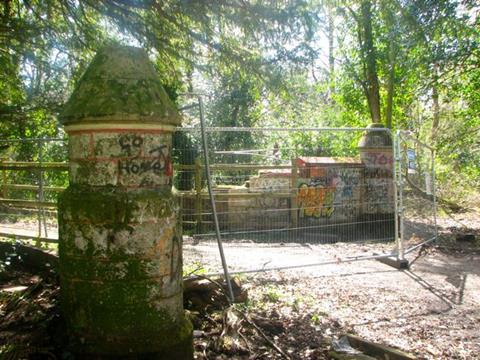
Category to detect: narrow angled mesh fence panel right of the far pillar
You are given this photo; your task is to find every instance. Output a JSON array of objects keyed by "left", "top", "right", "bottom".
[{"left": 397, "top": 131, "right": 437, "bottom": 254}]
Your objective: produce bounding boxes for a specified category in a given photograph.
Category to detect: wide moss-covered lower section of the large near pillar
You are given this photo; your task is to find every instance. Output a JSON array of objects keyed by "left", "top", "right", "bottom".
[{"left": 59, "top": 184, "right": 193, "bottom": 359}]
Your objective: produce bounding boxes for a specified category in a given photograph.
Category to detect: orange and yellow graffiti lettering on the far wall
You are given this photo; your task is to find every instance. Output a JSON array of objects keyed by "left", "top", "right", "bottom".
[{"left": 297, "top": 184, "right": 335, "bottom": 218}]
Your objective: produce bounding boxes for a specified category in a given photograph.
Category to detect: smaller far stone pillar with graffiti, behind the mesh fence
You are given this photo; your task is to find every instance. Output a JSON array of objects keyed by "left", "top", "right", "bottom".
[{"left": 358, "top": 123, "right": 395, "bottom": 238}]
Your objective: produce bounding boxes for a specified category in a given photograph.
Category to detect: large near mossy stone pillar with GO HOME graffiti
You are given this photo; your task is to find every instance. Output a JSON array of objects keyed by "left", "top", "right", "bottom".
[{"left": 58, "top": 46, "right": 193, "bottom": 359}]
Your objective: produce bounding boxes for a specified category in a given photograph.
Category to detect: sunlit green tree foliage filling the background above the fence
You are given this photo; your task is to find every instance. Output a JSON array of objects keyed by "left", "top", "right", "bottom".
[{"left": 0, "top": 0, "right": 480, "bottom": 202}]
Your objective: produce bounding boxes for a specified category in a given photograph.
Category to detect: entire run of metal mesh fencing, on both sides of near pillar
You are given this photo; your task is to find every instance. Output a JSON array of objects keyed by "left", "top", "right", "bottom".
[{"left": 0, "top": 128, "right": 436, "bottom": 273}]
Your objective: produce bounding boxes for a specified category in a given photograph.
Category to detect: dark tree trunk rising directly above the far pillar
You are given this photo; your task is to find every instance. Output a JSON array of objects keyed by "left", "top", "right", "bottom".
[{"left": 361, "top": 0, "right": 381, "bottom": 123}]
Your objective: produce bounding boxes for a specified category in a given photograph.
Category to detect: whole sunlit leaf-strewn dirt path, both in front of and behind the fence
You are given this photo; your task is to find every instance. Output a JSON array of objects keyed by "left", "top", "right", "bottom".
[{"left": 181, "top": 211, "right": 480, "bottom": 360}]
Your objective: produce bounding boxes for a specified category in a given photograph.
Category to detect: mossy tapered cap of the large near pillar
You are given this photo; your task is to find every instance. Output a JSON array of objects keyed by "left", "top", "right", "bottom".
[{"left": 59, "top": 45, "right": 180, "bottom": 126}]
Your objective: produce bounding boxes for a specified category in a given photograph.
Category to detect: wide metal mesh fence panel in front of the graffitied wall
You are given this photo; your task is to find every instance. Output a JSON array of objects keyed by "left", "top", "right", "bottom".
[{"left": 174, "top": 128, "right": 396, "bottom": 272}]
